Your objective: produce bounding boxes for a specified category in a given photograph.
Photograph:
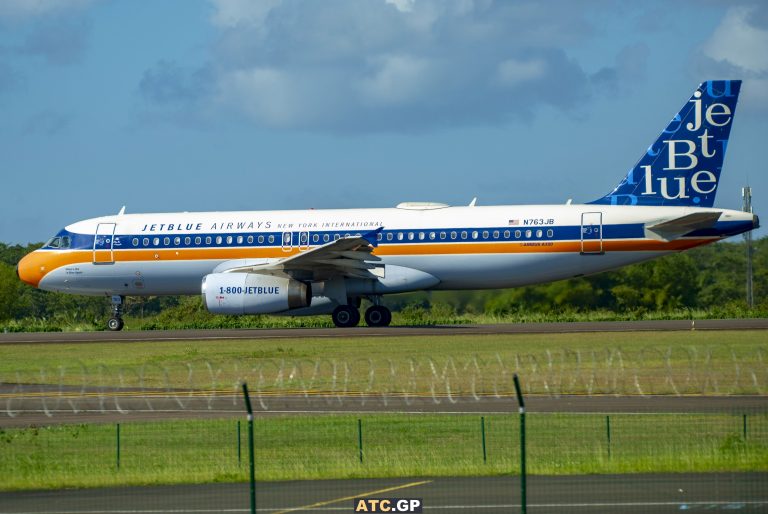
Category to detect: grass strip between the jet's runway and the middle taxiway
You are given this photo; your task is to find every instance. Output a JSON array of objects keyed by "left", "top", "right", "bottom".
[{"left": 0, "top": 331, "right": 768, "bottom": 394}]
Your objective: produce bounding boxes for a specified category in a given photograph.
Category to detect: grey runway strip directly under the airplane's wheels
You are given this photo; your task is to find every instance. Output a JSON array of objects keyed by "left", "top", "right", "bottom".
[{"left": 0, "top": 318, "right": 768, "bottom": 344}]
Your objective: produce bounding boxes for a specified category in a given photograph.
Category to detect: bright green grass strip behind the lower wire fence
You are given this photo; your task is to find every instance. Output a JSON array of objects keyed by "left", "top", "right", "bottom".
[{"left": 0, "top": 413, "right": 768, "bottom": 490}]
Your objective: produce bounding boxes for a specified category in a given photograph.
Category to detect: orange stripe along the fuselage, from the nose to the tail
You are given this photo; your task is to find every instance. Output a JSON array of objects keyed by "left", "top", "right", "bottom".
[{"left": 19, "top": 238, "right": 717, "bottom": 287}]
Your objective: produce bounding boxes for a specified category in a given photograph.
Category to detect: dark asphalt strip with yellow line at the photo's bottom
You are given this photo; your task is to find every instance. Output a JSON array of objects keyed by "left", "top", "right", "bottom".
[{"left": 0, "top": 473, "right": 768, "bottom": 514}]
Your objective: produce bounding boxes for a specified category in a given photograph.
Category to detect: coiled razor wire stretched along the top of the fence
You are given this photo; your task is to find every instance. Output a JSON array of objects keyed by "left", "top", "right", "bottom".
[{"left": 0, "top": 346, "right": 768, "bottom": 417}]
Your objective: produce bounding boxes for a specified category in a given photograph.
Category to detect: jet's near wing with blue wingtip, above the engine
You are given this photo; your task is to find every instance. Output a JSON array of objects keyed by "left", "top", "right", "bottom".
[{"left": 224, "top": 227, "right": 383, "bottom": 280}]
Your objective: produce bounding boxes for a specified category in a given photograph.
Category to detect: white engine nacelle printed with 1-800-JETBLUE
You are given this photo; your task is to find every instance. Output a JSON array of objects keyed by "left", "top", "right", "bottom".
[{"left": 202, "top": 273, "right": 312, "bottom": 314}]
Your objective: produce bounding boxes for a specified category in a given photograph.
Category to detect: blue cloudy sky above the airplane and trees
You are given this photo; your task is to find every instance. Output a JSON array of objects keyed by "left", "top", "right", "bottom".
[{"left": 0, "top": 0, "right": 768, "bottom": 243}]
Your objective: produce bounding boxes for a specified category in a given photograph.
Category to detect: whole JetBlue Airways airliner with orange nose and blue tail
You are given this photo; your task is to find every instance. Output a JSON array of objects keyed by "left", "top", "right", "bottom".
[{"left": 17, "top": 80, "right": 759, "bottom": 330}]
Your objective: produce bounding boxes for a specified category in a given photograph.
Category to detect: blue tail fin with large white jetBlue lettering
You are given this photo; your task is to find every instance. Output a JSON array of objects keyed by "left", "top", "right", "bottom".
[{"left": 590, "top": 80, "right": 741, "bottom": 207}]
